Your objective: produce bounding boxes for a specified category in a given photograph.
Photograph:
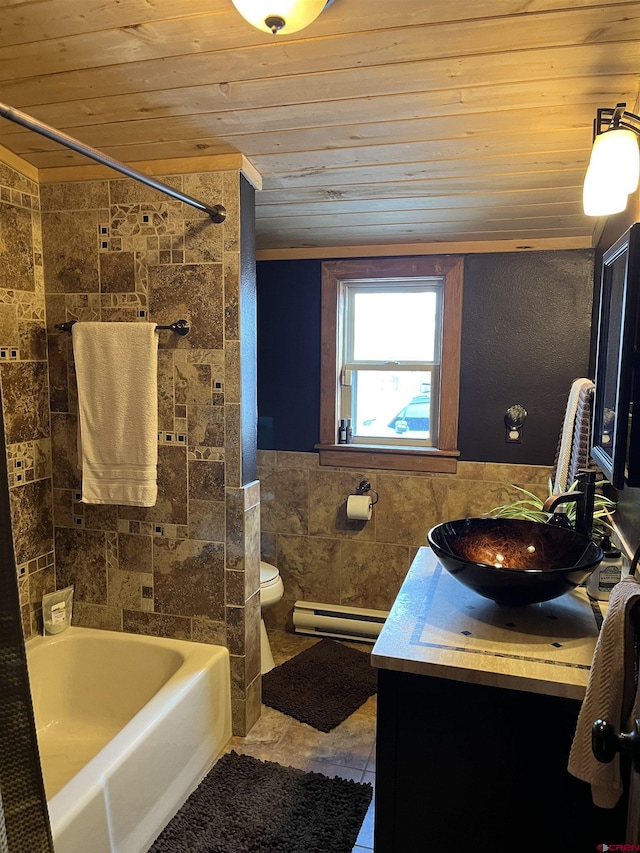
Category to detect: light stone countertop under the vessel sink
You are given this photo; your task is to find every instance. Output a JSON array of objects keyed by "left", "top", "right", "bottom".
[{"left": 372, "top": 547, "right": 606, "bottom": 699}]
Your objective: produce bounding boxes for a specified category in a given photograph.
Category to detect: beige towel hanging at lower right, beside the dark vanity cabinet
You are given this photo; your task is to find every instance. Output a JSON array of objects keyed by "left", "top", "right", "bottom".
[{"left": 569, "top": 578, "right": 640, "bottom": 809}]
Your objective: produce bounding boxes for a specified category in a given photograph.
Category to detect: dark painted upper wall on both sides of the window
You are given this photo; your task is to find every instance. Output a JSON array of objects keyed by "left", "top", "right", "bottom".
[{"left": 257, "top": 250, "right": 593, "bottom": 465}]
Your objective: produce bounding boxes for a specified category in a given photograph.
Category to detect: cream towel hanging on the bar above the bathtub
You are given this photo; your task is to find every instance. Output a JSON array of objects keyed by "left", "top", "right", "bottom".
[{"left": 72, "top": 323, "right": 158, "bottom": 506}]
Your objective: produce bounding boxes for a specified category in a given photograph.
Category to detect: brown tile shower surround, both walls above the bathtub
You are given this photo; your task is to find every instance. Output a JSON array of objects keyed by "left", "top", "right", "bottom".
[{"left": 0, "top": 155, "right": 260, "bottom": 734}]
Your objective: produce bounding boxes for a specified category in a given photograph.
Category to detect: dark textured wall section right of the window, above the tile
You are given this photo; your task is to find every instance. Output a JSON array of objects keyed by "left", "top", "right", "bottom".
[{"left": 458, "top": 250, "right": 593, "bottom": 465}]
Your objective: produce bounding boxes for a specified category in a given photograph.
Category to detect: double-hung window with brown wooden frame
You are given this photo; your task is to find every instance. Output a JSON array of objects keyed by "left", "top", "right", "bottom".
[{"left": 319, "top": 257, "right": 463, "bottom": 472}]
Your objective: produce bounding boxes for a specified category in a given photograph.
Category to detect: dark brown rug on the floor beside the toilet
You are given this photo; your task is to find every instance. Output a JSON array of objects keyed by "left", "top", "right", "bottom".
[{"left": 262, "top": 640, "right": 377, "bottom": 732}]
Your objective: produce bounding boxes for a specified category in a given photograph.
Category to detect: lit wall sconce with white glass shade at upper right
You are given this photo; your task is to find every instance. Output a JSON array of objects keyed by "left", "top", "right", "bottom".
[{"left": 582, "top": 104, "right": 640, "bottom": 216}]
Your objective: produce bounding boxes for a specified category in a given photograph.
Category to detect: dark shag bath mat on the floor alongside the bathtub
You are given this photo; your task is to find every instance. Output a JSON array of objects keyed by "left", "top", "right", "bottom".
[{"left": 149, "top": 752, "right": 373, "bottom": 853}]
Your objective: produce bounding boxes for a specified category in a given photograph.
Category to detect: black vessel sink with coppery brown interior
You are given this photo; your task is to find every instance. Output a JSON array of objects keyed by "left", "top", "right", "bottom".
[{"left": 428, "top": 518, "right": 602, "bottom": 604}]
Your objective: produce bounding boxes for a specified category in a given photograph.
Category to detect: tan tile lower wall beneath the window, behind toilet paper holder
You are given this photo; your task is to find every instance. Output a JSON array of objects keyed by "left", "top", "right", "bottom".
[{"left": 258, "top": 450, "right": 551, "bottom": 628}]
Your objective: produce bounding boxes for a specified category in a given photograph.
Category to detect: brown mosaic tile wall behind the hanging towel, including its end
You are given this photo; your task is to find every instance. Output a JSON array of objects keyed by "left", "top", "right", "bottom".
[{"left": 41, "top": 171, "right": 260, "bottom": 734}]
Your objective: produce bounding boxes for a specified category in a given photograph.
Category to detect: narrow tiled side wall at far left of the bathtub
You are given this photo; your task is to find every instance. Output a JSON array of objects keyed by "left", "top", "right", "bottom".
[{"left": 0, "top": 163, "right": 55, "bottom": 638}]
